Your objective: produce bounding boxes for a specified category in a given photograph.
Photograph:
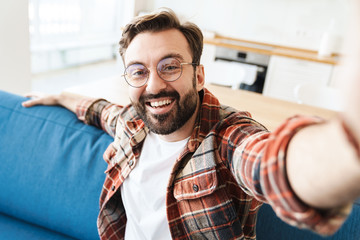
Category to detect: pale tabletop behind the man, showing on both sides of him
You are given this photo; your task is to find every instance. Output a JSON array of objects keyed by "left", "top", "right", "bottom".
[{"left": 65, "top": 77, "right": 337, "bottom": 130}]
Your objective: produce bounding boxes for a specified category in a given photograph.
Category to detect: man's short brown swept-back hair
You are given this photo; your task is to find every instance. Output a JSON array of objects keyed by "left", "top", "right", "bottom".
[{"left": 119, "top": 8, "right": 203, "bottom": 65}]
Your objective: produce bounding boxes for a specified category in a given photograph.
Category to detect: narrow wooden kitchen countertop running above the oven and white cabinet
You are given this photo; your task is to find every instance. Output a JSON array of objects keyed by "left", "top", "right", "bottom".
[{"left": 204, "top": 35, "right": 339, "bottom": 65}]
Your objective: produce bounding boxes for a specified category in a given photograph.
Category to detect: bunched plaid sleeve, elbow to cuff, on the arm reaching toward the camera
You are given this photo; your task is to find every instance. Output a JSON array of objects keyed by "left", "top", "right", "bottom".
[{"left": 231, "top": 116, "right": 352, "bottom": 235}]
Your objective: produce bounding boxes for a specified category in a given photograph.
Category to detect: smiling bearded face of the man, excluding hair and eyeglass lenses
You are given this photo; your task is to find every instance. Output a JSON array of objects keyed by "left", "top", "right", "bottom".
[{"left": 125, "top": 29, "right": 202, "bottom": 135}]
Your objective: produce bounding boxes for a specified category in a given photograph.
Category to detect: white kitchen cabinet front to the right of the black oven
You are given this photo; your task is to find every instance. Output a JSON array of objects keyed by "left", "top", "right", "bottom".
[{"left": 263, "top": 56, "right": 333, "bottom": 102}]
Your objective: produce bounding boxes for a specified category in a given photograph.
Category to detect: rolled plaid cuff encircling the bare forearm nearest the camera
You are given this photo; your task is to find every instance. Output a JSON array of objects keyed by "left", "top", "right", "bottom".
[{"left": 262, "top": 116, "right": 352, "bottom": 235}]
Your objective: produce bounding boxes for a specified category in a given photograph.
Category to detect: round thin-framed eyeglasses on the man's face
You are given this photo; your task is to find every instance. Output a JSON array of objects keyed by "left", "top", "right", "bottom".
[{"left": 122, "top": 57, "right": 197, "bottom": 88}]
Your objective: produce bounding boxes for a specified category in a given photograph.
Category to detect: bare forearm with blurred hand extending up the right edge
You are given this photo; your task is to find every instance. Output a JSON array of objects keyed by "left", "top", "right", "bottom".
[{"left": 287, "top": 1, "right": 360, "bottom": 208}]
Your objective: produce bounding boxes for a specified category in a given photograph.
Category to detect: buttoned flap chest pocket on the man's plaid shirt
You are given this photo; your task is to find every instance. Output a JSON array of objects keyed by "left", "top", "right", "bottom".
[{"left": 174, "top": 167, "right": 239, "bottom": 235}]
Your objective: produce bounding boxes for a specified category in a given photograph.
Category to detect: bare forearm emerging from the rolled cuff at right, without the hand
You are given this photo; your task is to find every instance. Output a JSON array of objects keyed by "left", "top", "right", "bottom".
[{"left": 286, "top": 119, "right": 360, "bottom": 209}]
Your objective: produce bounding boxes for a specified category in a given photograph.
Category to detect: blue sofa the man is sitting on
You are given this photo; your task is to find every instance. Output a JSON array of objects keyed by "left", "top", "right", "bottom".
[{"left": 0, "top": 91, "right": 360, "bottom": 240}]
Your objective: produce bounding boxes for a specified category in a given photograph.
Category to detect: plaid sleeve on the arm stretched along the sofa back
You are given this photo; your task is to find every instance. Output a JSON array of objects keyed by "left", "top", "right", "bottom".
[{"left": 76, "top": 98, "right": 123, "bottom": 137}]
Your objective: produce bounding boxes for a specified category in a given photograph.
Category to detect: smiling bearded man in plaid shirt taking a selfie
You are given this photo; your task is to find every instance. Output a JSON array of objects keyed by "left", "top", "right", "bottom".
[{"left": 23, "top": 7, "right": 360, "bottom": 239}]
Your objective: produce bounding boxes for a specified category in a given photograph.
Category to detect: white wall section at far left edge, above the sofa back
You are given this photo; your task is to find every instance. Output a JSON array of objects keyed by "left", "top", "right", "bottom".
[{"left": 0, "top": 0, "right": 31, "bottom": 94}]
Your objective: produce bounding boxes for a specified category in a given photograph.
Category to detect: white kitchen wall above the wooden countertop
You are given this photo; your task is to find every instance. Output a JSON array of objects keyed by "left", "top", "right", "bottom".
[{"left": 144, "top": 0, "right": 348, "bottom": 50}]
